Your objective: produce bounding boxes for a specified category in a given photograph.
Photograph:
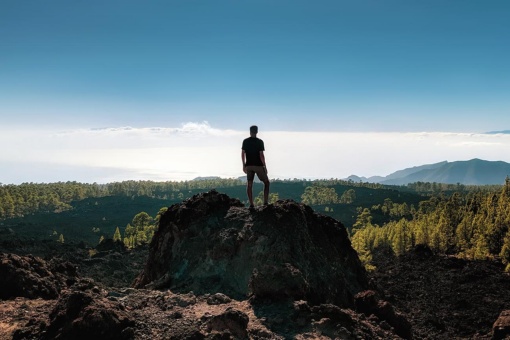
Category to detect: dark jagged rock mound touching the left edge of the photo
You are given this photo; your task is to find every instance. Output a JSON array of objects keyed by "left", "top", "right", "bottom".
[{"left": 0, "top": 253, "right": 77, "bottom": 299}]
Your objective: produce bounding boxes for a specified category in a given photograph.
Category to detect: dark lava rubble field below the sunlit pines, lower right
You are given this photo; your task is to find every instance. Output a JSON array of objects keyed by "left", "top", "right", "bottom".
[{"left": 370, "top": 247, "right": 510, "bottom": 340}]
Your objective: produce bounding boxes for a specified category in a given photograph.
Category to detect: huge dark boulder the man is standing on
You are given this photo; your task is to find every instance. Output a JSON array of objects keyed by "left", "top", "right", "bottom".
[{"left": 134, "top": 190, "right": 367, "bottom": 306}]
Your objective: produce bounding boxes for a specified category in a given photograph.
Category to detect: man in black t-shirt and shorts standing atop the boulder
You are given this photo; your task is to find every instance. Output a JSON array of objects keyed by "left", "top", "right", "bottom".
[{"left": 241, "top": 125, "right": 269, "bottom": 208}]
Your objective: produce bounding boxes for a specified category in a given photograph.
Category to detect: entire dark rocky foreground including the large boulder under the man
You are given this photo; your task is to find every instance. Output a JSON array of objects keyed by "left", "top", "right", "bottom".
[{"left": 0, "top": 191, "right": 510, "bottom": 339}]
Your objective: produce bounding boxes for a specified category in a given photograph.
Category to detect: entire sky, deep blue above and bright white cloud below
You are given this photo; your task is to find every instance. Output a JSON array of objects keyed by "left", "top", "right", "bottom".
[{"left": 0, "top": 0, "right": 510, "bottom": 184}]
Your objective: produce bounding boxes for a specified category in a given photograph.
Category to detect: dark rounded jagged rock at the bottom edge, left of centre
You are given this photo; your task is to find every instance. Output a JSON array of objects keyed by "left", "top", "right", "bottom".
[{"left": 43, "top": 291, "right": 135, "bottom": 340}]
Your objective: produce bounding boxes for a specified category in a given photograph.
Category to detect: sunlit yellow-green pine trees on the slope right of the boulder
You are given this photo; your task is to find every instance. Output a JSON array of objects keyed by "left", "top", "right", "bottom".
[{"left": 352, "top": 178, "right": 510, "bottom": 270}]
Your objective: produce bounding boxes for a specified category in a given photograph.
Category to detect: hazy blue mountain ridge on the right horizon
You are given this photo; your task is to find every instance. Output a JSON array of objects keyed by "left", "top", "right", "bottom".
[{"left": 347, "top": 158, "right": 510, "bottom": 185}]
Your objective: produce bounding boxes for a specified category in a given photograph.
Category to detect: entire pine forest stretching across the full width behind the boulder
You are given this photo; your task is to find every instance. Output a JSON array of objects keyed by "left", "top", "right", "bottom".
[{"left": 0, "top": 178, "right": 510, "bottom": 266}]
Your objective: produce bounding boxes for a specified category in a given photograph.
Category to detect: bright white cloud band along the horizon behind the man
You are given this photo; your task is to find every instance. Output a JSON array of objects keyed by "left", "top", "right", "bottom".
[{"left": 0, "top": 122, "right": 510, "bottom": 183}]
